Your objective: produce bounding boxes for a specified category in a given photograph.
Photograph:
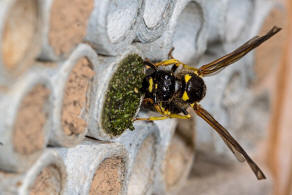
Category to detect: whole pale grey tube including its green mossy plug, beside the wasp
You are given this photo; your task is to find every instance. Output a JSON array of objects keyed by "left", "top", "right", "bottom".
[{"left": 88, "top": 47, "right": 144, "bottom": 140}]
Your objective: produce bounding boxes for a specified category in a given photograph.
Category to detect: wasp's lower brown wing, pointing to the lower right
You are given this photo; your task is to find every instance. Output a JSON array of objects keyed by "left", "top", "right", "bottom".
[{"left": 192, "top": 104, "right": 266, "bottom": 180}]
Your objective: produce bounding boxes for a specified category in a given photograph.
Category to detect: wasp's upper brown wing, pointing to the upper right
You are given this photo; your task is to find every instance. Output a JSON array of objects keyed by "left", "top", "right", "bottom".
[{"left": 198, "top": 26, "right": 281, "bottom": 76}]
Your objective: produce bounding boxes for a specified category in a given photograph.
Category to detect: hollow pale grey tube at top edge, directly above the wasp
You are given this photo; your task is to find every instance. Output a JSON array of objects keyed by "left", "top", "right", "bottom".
[{"left": 136, "top": 0, "right": 208, "bottom": 63}]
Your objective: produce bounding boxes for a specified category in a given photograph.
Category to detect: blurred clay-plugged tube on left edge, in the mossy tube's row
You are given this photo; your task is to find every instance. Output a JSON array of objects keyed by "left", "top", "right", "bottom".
[{"left": 0, "top": 69, "right": 52, "bottom": 172}]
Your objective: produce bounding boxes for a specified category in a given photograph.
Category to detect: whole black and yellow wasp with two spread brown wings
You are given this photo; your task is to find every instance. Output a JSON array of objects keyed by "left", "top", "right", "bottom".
[{"left": 135, "top": 26, "right": 281, "bottom": 180}]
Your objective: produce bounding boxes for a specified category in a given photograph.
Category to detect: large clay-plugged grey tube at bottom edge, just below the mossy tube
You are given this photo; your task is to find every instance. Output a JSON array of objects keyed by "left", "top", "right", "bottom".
[{"left": 57, "top": 139, "right": 129, "bottom": 195}]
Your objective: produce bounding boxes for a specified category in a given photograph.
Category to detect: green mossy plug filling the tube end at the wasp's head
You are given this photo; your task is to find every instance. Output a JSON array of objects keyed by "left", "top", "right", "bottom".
[{"left": 102, "top": 54, "right": 144, "bottom": 136}]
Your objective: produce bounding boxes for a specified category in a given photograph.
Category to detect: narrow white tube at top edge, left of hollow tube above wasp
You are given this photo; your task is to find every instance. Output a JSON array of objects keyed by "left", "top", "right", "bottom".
[{"left": 136, "top": 0, "right": 175, "bottom": 43}]
